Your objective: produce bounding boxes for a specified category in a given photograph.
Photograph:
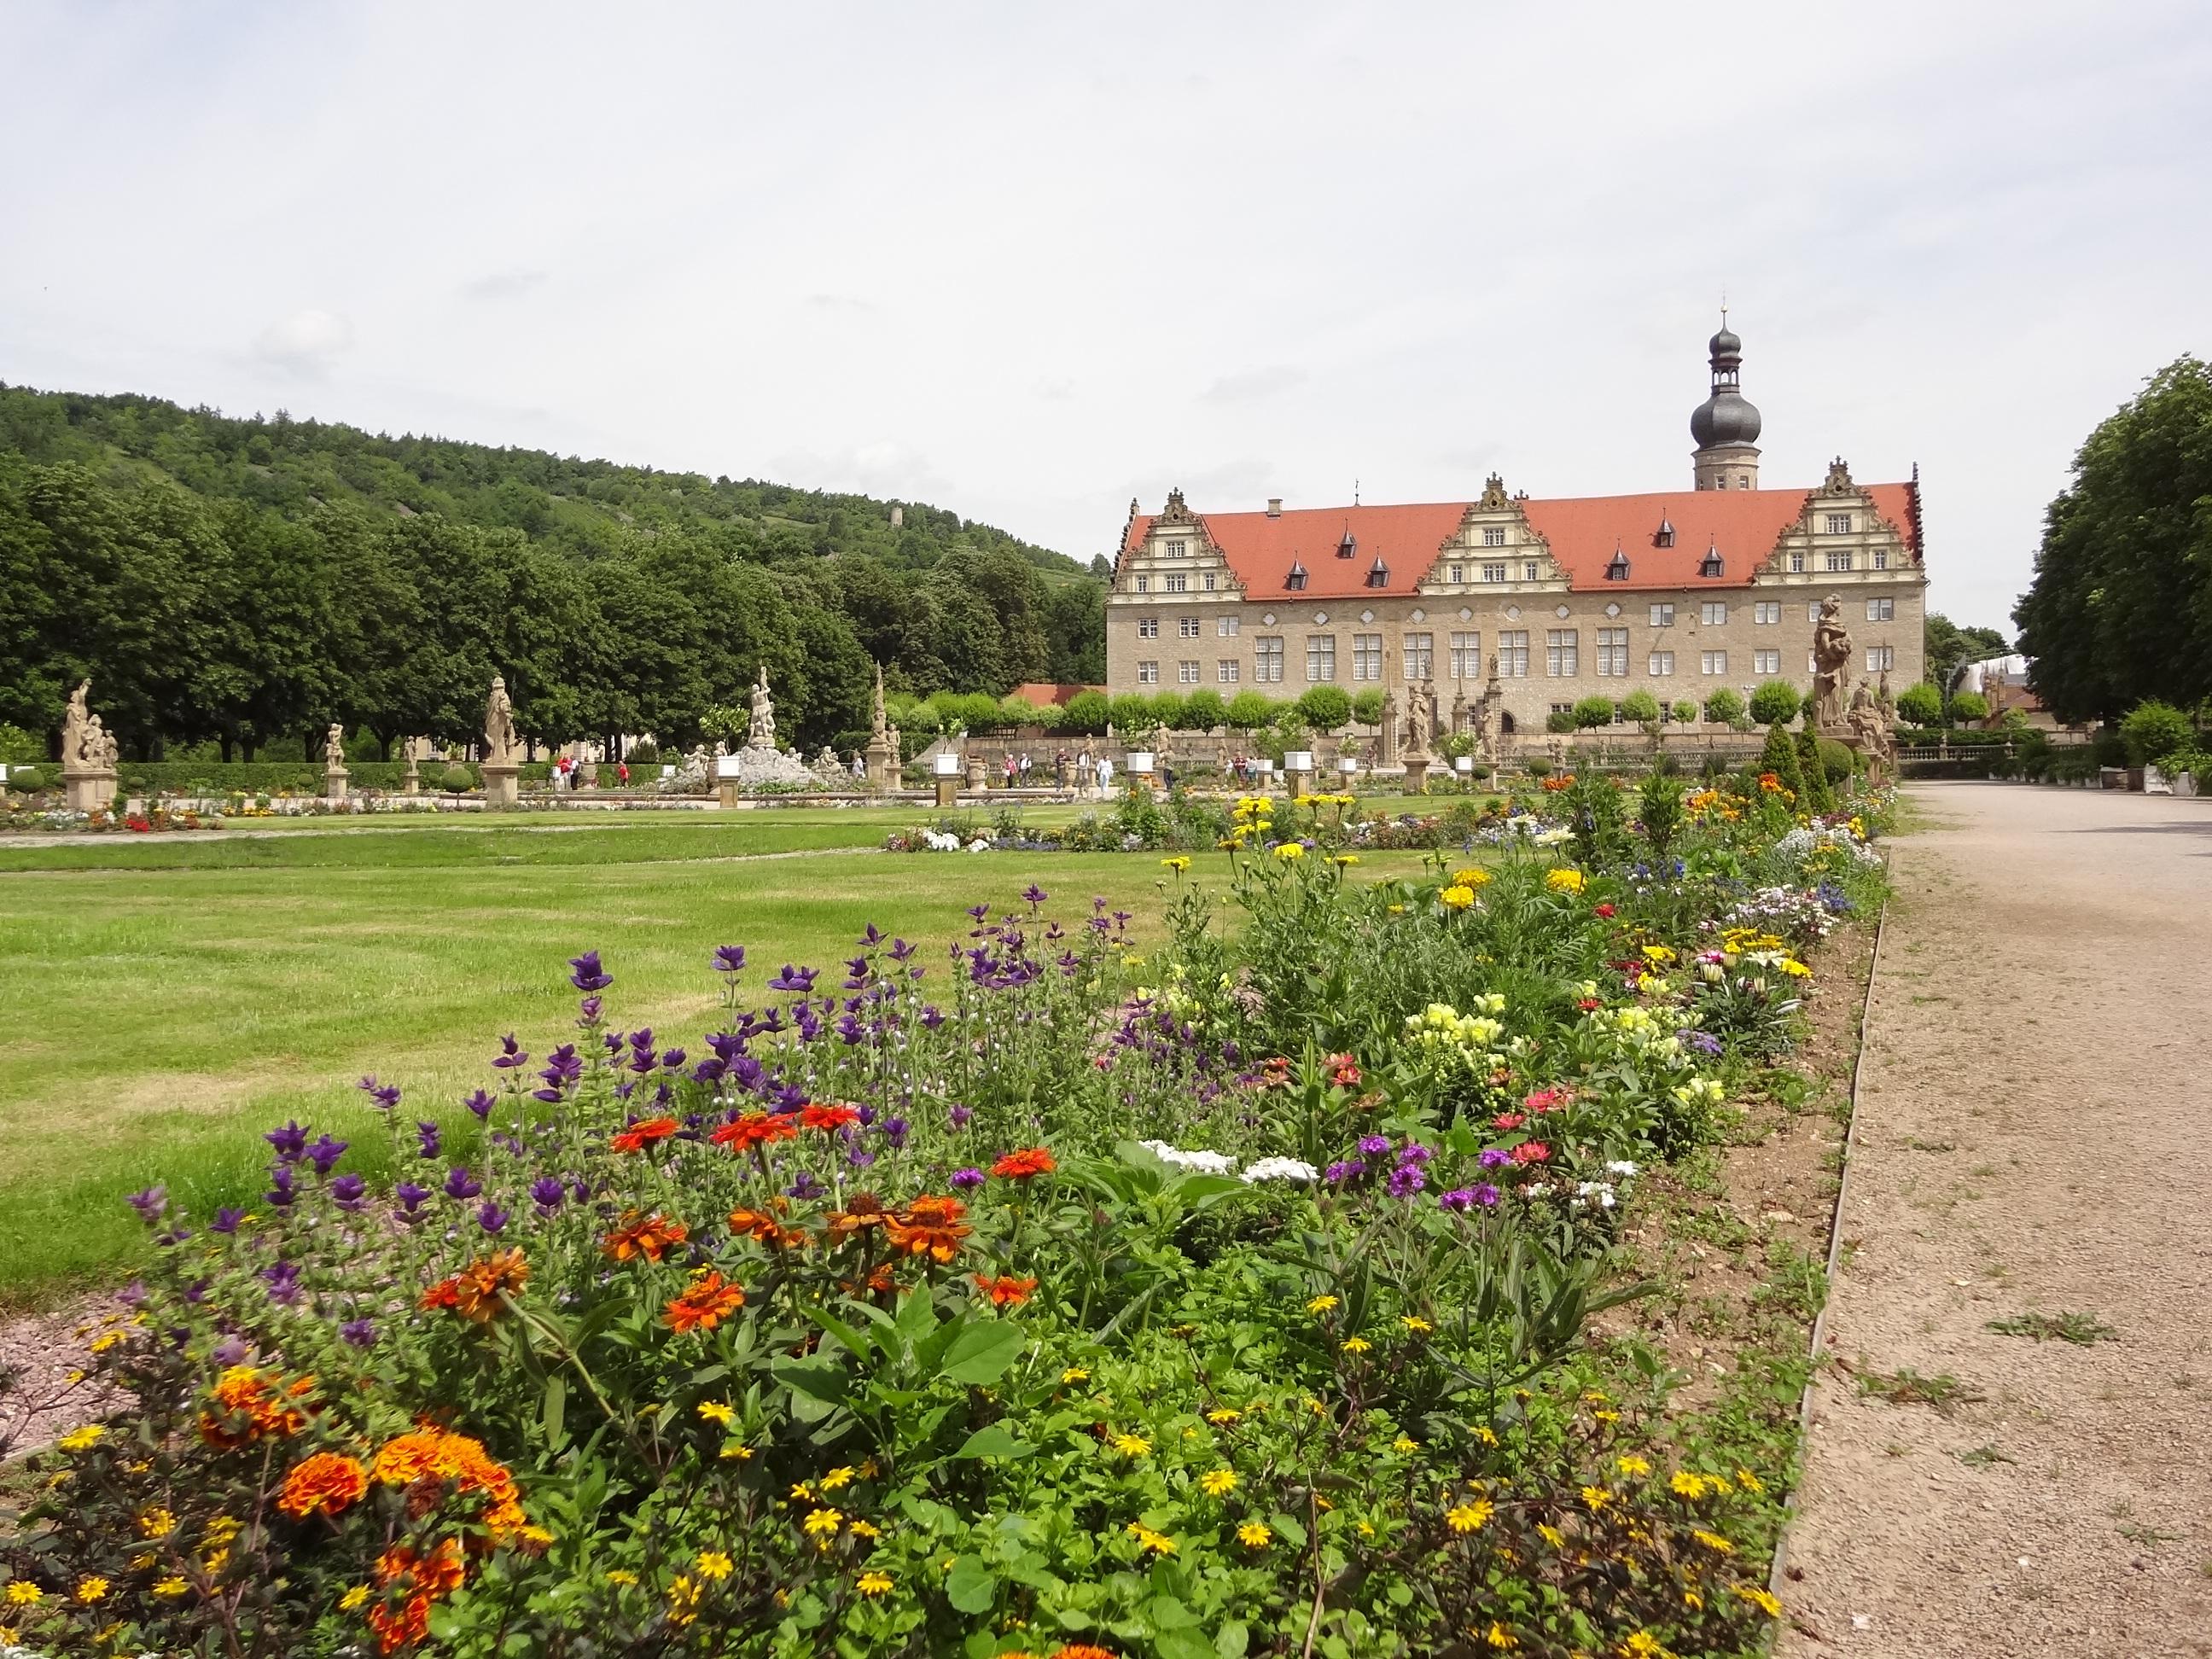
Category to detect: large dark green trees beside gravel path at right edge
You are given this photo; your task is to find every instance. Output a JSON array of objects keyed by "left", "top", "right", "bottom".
[{"left": 2013, "top": 356, "right": 2212, "bottom": 721}]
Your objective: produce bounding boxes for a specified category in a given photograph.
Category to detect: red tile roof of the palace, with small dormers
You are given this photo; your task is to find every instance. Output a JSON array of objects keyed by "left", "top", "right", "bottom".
[{"left": 1121, "top": 485, "right": 1920, "bottom": 599}]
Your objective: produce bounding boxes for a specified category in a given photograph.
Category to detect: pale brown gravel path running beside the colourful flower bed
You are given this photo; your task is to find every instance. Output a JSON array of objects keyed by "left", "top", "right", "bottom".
[{"left": 1778, "top": 783, "right": 2212, "bottom": 1659}]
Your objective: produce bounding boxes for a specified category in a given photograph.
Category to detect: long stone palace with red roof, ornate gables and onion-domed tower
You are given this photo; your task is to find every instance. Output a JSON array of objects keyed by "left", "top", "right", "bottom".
[{"left": 1106, "top": 323, "right": 1927, "bottom": 732}]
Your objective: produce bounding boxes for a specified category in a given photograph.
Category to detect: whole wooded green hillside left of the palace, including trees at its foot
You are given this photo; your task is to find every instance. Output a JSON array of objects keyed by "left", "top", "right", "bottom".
[{"left": 0, "top": 385, "right": 1106, "bottom": 754}]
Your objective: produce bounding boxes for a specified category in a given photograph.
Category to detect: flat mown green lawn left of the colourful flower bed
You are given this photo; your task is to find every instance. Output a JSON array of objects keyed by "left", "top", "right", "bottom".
[{"left": 0, "top": 827, "right": 1420, "bottom": 1303}]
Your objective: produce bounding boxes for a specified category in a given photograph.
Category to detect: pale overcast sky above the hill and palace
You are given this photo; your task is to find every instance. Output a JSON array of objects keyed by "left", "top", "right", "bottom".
[{"left": 0, "top": 0, "right": 2212, "bottom": 631}]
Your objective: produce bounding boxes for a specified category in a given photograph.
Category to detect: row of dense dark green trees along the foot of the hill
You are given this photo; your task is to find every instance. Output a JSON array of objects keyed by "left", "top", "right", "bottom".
[{"left": 0, "top": 393, "right": 1103, "bottom": 759}]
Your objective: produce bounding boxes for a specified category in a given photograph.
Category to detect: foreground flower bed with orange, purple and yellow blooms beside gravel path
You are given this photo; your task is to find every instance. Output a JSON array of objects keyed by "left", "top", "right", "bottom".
[{"left": 0, "top": 781, "right": 1880, "bottom": 1659}]
